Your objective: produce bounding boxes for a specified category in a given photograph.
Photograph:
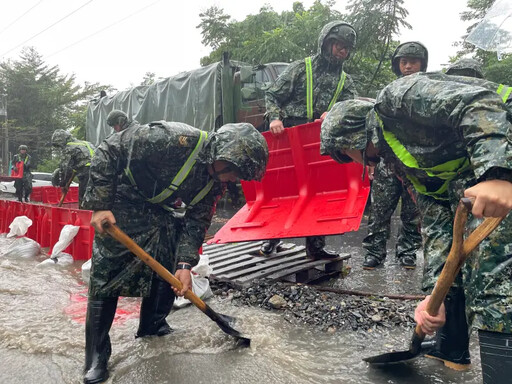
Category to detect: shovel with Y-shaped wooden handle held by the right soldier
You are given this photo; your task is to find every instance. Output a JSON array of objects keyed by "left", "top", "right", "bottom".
[{"left": 363, "top": 198, "right": 504, "bottom": 366}]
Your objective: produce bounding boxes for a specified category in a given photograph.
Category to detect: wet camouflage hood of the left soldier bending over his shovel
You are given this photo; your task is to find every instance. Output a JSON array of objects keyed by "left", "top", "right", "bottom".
[{"left": 200, "top": 123, "right": 268, "bottom": 180}]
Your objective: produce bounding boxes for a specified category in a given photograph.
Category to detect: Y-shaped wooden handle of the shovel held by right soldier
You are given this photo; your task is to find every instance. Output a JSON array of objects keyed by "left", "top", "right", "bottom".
[{"left": 415, "top": 200, "right": 504, "bottom": 338}]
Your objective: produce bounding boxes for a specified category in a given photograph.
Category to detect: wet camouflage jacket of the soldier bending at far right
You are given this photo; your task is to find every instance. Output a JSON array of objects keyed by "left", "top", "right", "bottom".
[{"left": 369, "top": 73, "right": 512, "bottom": 198}]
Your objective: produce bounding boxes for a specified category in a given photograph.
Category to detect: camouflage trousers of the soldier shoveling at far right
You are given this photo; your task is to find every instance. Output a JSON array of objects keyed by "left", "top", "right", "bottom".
[{"left": 418, "top": 190, "right": 512, "bottom": 333}]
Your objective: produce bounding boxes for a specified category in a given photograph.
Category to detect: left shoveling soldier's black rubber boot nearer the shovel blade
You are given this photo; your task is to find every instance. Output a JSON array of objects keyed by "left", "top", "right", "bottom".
[{"left": 135, "top": 278, "right": 176, "bottom": 337}]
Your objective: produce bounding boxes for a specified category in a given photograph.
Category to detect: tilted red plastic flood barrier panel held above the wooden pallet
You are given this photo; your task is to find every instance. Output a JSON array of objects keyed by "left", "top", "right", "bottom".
[{"left": 210, "top": 121, "right": 370, "bottom": 243}]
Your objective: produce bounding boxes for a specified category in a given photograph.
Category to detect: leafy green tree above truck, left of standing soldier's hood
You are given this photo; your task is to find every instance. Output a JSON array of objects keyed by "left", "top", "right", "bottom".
[{"left": 197, "top": 0, "right": 342, "bottom": 65}]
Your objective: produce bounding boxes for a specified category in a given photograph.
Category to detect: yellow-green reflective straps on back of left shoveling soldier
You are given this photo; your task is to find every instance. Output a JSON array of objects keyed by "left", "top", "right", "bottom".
[{"left": 124, "top": 131, "right": 214, "bottom": 212}]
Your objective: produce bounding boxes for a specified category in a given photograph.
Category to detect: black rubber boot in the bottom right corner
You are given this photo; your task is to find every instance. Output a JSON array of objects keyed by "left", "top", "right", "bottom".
[{"left": 478, "top": 330, "right": 512, "bottom": 384}]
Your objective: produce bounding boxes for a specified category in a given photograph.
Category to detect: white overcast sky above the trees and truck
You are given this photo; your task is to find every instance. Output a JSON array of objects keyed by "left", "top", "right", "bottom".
[{"left": 0, "top": 0, "right": 467, "bottom": 90}]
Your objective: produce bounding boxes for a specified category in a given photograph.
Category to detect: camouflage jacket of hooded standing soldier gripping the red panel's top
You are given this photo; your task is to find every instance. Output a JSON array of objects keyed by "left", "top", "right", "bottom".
[{"left": 265, "top": 23, "right": 357, "bottom": 122}]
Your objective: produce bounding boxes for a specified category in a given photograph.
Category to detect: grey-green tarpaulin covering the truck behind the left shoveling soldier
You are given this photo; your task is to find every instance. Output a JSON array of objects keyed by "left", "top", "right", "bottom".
[{"left": 86, "top": 63, "right": 222, "bottom": 145}]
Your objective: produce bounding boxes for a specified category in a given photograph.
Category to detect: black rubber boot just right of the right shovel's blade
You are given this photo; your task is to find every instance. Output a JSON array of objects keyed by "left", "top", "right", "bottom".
[{"left": 425, "top": 288, "right": 471, "bottom": 371}]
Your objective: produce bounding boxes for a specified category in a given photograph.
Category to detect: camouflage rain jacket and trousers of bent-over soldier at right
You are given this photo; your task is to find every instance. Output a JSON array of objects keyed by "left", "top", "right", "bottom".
[{"left": 370, "top": 74, "right": 512, "bottom": 333}]
